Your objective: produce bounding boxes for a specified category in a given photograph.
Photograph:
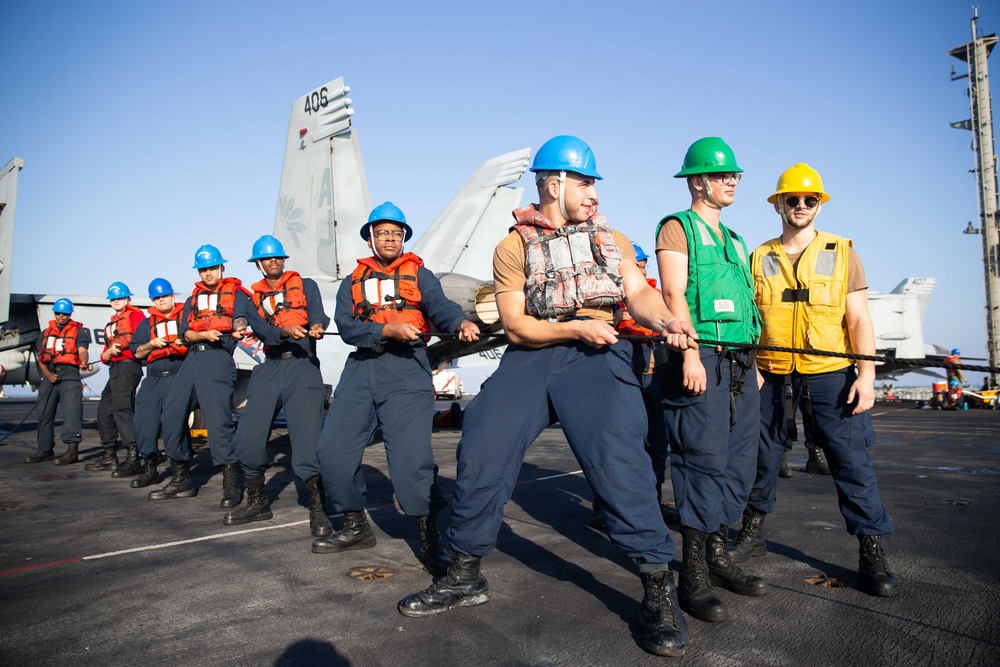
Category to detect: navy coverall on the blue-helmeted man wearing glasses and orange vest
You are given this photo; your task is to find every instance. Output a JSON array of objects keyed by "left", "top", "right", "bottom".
[{"left": 316, "top": 267, "right": 466, "bottom": 516}]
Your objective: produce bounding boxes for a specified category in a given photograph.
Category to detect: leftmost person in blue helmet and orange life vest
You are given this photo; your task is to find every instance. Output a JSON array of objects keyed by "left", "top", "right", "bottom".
[{"left": 25, "top": 299, "right": 90, "bottom": 465}]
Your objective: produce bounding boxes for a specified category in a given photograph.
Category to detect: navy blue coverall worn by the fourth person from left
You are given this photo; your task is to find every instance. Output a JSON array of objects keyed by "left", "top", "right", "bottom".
[{"left": 163, "top": 290, "right": 249, "bottom": 465}]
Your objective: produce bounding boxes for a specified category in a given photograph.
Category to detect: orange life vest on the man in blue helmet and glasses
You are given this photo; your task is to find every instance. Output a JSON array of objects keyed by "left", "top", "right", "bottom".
[{"left": 351, "top": 252, "right": 431, "bottom": 333}]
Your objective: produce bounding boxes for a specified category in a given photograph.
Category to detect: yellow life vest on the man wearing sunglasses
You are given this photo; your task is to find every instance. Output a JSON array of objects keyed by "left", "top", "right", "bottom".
[{"left": 753, "top": 232, "right": 854, "bottom": 375}]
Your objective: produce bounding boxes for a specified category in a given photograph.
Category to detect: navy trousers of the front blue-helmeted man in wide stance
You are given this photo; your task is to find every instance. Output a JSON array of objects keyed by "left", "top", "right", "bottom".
[{"left": 448, "top": 340, "right": 674, "bottom": 572}]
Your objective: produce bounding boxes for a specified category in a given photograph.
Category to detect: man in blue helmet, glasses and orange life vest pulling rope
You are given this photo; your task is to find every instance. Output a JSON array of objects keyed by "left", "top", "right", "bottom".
[{"left": 312, "top": 202, "right": 479, "bottom": 574}]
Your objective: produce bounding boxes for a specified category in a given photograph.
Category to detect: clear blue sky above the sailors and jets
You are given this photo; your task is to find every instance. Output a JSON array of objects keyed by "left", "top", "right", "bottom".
[{"left": 0, "top": 0, "right": 1000, "bottom": 383}]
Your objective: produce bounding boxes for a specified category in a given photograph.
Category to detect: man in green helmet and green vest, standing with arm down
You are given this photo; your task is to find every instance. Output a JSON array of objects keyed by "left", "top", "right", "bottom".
[{"left": 656, "top": 137, "right": 769, "bottom": 623}]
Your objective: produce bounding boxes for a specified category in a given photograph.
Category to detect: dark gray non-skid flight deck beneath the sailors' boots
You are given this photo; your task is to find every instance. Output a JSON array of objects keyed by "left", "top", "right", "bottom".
[{"left": 0, "top": 400, "right": 1000, "bottom": 666}]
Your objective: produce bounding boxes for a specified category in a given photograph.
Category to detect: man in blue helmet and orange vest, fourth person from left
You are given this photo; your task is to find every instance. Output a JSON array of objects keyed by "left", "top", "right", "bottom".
[{"left": 149, "top": 245, "right": 250, "bottom": 509}]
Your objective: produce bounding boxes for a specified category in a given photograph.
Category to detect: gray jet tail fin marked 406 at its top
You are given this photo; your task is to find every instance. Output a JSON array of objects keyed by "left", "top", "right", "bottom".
[{"left": 274, "top": 77, "right": 371, "bottom": 281}]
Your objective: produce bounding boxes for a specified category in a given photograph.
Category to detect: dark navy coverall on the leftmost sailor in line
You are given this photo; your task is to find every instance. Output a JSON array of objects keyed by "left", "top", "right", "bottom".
[{"left": 35, "top": 326, "right": 90, "bottom": 452}]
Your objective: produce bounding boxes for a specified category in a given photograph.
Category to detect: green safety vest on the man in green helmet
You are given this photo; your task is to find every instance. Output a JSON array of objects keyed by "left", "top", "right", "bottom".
[{"left": 656, "top": 209, "right": 760, "bottom": 344}]
